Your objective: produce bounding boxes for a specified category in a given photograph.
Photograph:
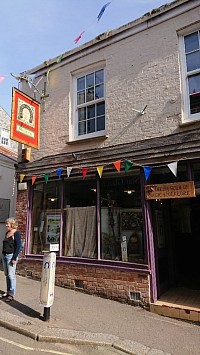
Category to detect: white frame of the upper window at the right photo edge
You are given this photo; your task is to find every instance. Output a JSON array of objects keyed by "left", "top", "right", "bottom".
[{"left": 178, "top": 23, "right": 200, "bottom": 124}]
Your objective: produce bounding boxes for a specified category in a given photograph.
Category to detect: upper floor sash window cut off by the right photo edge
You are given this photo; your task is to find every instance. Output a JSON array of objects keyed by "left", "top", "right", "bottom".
[{"left": 183, "top": 30, "right": 200, "bottom": 121}]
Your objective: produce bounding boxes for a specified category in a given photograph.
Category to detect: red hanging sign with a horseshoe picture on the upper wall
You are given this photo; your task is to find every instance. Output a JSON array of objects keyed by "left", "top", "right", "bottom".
[{"left": 10, "top": 88, "right": 40, "bottom": 149}]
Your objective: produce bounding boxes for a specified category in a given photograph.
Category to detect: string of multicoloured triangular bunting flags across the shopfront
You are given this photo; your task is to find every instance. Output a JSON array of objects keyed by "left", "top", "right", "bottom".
[{"left": 19, "top": 160, "right": 178, "bottom": 185}]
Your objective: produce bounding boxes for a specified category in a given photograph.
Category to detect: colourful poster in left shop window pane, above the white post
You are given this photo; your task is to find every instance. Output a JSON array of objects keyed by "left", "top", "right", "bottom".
[{"left": 46, "top": 214, "right": 61, "bottom": 244}]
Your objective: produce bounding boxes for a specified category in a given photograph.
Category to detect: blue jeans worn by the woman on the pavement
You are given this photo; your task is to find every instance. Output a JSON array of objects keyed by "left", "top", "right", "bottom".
[{"left": 2, "top": 254, "right": 16, "bottom": 296}]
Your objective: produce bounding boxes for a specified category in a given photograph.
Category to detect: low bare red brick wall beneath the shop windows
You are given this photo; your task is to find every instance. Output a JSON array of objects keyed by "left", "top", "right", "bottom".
[{"left": 17, "top": 260, "right": 150, "bottom": 309}]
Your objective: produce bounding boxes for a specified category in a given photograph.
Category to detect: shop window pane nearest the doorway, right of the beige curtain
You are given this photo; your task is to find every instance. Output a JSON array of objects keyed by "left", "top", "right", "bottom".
[{"left": 100, "top": 175, "right": 145, "bottom": 263}]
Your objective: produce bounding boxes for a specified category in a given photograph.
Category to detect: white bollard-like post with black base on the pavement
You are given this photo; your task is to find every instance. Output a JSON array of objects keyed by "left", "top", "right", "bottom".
[{"left": 40, "top": 252, "right": 56, "bottom": 321}]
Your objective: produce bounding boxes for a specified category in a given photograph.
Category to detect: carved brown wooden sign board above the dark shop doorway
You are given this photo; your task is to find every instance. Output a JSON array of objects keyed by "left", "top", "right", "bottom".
[{"left": 145, "top": 181, "right": 196, "bottom": 200}]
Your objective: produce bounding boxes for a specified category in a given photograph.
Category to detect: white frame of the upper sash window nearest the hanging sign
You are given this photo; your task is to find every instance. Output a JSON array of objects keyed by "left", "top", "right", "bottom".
[{"left": 70, "top": 65, "right": 106, "bottom": 141}]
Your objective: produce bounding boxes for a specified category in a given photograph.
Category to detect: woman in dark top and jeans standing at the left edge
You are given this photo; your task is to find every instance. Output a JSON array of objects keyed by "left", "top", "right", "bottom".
[{"left": 2, "top": 217, "right": 21, "bottom": 302}]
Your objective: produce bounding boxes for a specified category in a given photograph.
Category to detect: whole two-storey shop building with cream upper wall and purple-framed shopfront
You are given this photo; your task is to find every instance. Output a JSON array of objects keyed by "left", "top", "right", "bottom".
[{"left": 14, "top": 0, "right": 200, "bottom": 320}]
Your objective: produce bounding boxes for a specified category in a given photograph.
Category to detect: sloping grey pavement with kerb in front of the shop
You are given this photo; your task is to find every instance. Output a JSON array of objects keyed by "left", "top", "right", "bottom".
[{"left": 0, "top": 271, "right": 200, "bottom": 355}]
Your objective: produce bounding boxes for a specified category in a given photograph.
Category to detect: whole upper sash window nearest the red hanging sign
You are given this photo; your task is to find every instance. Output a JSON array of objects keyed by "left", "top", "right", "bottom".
[{"left": 76, "top": 69, "right": 105, "bottom": 138}]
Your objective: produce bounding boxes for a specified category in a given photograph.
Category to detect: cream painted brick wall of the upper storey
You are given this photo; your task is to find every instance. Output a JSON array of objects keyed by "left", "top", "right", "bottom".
[{"left": 19, "top": 5, "right": 200, "bottom": 160}]
